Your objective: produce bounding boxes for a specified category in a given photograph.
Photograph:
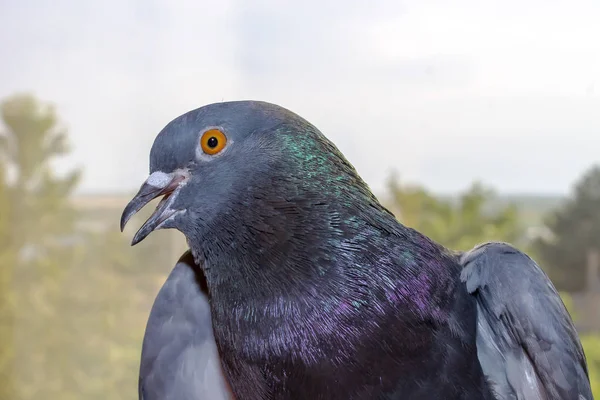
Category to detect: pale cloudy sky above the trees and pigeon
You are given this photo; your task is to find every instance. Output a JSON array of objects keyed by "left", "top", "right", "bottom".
[{"left": 0, "top": 0, "right": 600, "bottom": 194}]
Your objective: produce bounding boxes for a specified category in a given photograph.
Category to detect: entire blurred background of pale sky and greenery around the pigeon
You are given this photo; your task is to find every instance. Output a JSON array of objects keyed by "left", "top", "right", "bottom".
[{"left": 0, "top": 0, "right": 600, "bottom": 400}]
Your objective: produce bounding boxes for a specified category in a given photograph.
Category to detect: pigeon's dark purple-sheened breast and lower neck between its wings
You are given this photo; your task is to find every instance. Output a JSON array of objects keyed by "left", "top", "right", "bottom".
[{"left": 206, "top": 197, "right": 491, "bottom": 400}]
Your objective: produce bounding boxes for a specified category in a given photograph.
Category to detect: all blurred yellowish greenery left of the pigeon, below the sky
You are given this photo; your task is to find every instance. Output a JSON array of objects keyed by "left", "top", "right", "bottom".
[{"left": 0, "top": 91, "right": 183, "bottom": 400}]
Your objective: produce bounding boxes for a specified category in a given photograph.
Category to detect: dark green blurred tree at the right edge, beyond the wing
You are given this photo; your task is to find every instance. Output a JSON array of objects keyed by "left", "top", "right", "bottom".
[{"left": 534, "top": 166, "right": 600, "bottom": 292}]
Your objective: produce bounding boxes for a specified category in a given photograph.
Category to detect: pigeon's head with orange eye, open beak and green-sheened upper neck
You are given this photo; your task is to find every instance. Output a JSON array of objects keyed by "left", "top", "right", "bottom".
[{"left": 121, "top": 101, "right": 384, "bottom": 262}]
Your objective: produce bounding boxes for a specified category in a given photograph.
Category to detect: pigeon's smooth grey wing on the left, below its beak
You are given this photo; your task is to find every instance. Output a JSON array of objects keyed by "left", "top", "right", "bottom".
[{"left": 139, "top": 252, "right": 232, "bottom": 400}]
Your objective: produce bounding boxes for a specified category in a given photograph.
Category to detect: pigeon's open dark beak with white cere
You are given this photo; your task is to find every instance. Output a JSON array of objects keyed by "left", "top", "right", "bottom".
[{"left": 121, "top": 170, "right": 188, "bottom": 246}]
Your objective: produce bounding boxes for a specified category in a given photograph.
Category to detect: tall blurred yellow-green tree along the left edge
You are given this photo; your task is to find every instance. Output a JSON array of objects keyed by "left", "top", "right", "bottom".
[{"left": 0, "top": 94, "right": 79, "bottom": 399}]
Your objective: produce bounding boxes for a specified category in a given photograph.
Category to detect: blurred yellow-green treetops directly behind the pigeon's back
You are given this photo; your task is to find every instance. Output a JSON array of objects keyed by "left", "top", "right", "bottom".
[{"left": 388, "top": 174, "right": 523, "bottom": 250}]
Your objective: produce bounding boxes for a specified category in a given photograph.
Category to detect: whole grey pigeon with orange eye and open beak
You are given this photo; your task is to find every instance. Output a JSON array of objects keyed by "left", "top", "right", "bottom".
[{"left": 121, "top": 101, "right": 593, "bottom": 400}]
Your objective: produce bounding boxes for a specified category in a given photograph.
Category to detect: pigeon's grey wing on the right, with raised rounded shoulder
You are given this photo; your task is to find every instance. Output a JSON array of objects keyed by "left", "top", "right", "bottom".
[{"left": 461, "top": 243, "right": 593, "bottom": 400}]
